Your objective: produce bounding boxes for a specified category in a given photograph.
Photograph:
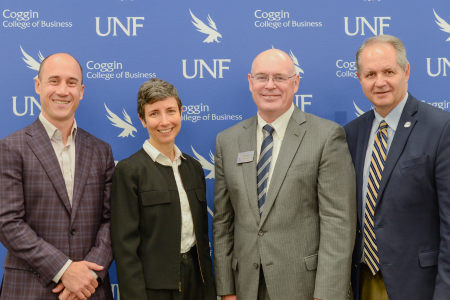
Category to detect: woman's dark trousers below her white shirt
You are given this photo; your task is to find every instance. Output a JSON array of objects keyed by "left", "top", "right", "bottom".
[{"left": 147, "top": 246, "right": 204, "bottom": 300}]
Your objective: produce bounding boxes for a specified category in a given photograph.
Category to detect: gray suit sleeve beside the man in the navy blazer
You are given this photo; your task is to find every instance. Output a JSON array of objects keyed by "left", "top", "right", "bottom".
[{"left": 314, "top": 125, "right": 356, "bottom": 300}]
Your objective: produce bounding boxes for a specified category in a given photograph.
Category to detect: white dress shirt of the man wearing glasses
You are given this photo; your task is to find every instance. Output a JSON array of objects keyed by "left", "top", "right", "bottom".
[{"left": 256, "top": 103, "right": 294, "bottom": 194}]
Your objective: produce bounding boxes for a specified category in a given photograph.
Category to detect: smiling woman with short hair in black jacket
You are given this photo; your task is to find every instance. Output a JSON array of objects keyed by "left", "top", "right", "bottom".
[{"left": 111, "top": 78, "right": 216, "bottom": 300}]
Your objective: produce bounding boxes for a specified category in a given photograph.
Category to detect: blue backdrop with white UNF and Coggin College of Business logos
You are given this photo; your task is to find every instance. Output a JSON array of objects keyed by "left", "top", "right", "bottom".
[{"left": 0, "top": 0, "right": 450, "bottom": 299}]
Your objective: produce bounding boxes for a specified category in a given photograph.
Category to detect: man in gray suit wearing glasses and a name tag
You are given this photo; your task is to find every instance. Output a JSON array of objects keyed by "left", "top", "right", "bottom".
[{"left": 213, "top": 49, "right": 356, "bottom": 300}]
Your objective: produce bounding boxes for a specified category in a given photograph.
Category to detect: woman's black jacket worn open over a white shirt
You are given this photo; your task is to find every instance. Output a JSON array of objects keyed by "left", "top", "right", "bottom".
[{"left": 111, "top": 149, "right": 216, "bottom": 300}]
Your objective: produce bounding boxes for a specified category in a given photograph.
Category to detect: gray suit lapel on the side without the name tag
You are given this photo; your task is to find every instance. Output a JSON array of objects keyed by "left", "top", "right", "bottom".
[{"left": 259, "top": 107, "right": 306, "bottom": 227}]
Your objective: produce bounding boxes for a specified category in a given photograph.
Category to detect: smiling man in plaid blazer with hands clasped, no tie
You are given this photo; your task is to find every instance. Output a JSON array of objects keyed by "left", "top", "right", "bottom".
[{"left": 0, "top": 53, "right": 114, "bottom": 300}]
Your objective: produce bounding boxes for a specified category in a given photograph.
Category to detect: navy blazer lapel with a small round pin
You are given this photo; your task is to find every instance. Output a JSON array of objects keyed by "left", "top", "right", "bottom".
[{"left": 377, "top": 94, "right": 418, "bottom": 208}]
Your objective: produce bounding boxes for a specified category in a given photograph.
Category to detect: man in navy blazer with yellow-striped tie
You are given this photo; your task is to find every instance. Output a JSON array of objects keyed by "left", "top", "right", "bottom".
[{"left": 345, "top": 35, "right": 450, "bottom": 300}]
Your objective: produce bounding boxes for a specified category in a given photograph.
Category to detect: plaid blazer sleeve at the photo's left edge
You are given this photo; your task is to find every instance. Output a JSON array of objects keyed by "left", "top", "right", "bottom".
[{"left": 0, "top": 140, "right": 69, "bottom": 287}]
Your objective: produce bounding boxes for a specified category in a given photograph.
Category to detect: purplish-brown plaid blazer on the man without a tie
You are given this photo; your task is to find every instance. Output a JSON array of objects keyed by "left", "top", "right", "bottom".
[{"left": 0, "top": 119, "right": 114, "bottom": 300}]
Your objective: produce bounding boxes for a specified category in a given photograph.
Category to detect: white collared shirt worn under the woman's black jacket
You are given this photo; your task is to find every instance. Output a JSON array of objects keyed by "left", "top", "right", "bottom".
[{"left": 142, "top": 140, "right": 196, "bottom": 253}]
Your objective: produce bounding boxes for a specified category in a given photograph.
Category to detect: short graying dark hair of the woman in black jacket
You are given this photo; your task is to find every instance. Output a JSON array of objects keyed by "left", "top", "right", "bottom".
[{"left": 138, "top": 78, "right": 182, "bottom": 120}]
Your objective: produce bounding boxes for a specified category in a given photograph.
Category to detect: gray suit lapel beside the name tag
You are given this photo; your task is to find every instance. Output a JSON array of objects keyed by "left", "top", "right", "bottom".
[{"left": 236, "top": 116, "right": 260, "bottom": 221}]
